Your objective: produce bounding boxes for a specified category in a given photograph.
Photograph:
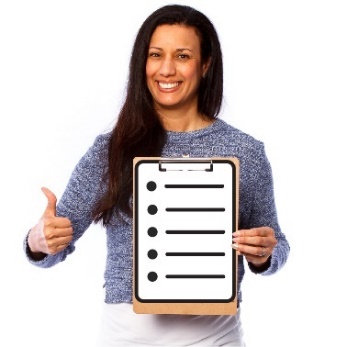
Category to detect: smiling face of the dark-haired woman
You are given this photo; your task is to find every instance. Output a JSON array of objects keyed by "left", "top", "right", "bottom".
[{"left": 146, "top": 25, "right": 207, "bottom": 112}]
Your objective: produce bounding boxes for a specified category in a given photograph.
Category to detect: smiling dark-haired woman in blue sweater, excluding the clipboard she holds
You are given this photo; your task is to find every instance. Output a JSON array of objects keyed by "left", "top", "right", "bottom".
[{"left": 24, "top": 5, "right": 289, "bottom": 346}]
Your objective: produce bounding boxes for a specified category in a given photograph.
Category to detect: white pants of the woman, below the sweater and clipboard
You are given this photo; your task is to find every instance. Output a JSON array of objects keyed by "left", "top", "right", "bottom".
[{"left": 98, "top": 303, "right": 245, "bottom": 347}]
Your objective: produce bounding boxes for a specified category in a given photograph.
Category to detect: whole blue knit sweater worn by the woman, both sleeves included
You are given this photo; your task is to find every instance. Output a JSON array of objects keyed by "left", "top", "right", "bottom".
[{"left": 24, "top": 119, "right": 289, "bottom": 303}]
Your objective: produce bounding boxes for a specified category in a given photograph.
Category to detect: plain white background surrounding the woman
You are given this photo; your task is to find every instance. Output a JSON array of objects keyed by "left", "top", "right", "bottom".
[{"left": 0, "top": 0, "right": 347, "bottom": 347}]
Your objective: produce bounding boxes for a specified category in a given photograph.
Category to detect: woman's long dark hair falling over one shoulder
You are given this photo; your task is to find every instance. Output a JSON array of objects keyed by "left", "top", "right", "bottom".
[{"left": 93, "top": 5, "right": 223, "bottom": 225}]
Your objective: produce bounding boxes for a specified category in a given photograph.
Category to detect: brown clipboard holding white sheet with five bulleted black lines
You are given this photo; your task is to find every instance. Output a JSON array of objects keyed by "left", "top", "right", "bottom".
[{"left": 133, "top": 157, "right": 239, "bottom": 315}]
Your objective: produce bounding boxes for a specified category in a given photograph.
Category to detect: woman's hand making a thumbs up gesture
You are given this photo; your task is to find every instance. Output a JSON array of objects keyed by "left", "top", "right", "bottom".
[{"left": 28, "top": 187, "right": 73, "bottom": 254}]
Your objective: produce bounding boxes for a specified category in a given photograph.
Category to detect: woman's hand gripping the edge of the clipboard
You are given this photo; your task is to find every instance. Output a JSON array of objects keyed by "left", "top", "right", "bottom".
[{"left": 232, "top": 227, "right": 277, "bottom": 266}]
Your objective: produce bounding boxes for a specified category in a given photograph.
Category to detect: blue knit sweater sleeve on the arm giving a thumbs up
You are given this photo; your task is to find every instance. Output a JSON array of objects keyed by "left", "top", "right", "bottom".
[{"left": 24, "top": 135, "right": 108, "bottom": 268}]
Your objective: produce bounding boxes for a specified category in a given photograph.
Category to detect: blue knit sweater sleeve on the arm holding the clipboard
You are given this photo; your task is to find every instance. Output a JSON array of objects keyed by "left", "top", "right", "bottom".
[{"left": 249, "top": 145, "right": 290, "bottom": 275}]
